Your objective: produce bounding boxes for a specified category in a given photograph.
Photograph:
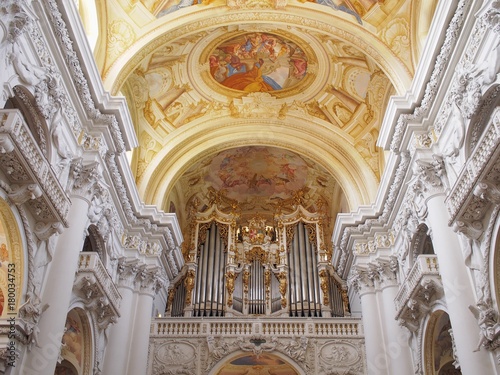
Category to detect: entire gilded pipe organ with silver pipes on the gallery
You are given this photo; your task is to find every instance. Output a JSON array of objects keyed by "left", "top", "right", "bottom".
[{"left": 166, "top": 205, "right": 350, "bottom": 317}]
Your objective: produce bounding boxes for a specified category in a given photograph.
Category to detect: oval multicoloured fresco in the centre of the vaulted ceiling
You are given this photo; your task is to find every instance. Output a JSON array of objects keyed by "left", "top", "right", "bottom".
[{"left": 209, "top": 32, "right": 307, "bottom": 92}]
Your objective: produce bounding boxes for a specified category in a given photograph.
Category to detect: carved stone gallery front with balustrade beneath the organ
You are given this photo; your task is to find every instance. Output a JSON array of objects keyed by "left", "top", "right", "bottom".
[{"left": 149, "top": 317, "right": 365, "bottom": 375}]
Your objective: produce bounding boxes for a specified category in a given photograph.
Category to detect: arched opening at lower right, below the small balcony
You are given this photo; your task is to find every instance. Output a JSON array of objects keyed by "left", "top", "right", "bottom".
[{"left": 424, "top": 310, "right": 462, "bottom": 375}]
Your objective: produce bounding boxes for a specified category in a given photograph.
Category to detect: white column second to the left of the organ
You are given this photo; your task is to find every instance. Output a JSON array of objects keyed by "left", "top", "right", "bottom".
[{"left": 103, "top": 259, "right": 141, "bottom": 375}]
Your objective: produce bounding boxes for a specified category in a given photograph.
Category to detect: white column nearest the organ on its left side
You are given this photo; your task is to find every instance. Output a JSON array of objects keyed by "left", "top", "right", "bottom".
[{"left": 127, "top": 269, "right": 165, "bottom": 375}]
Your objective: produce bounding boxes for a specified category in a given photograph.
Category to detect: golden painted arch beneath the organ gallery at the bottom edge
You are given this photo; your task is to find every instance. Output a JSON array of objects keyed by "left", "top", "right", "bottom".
[{"left": 208, "top": 350, "right": 306, "bottom": 375}]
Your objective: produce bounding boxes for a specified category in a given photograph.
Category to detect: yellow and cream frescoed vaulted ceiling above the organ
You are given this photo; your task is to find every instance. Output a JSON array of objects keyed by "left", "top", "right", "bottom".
[{"left": 77, "top": 0, "right": 437, "bottom": 241}]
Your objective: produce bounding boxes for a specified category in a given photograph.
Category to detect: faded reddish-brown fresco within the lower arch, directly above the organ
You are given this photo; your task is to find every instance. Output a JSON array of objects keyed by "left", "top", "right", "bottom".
[{"left": 174, "top": 146, "right": 342, "bottom": 228}]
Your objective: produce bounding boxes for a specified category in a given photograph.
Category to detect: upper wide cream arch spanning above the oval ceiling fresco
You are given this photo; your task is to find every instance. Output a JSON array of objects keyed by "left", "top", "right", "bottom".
[{"left": 102, "top": 3, "right": 412, "bottom": 95}]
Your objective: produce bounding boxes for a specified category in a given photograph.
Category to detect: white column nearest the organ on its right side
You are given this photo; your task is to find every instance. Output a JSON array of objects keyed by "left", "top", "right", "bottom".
[{"left": 351, "top": 266, "right": 388, "bottom": 375}]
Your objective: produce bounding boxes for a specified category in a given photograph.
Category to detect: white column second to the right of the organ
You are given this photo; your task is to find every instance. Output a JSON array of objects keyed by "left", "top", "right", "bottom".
[{"left": 377, "top": 257, "right": 415, "bottom": 375}]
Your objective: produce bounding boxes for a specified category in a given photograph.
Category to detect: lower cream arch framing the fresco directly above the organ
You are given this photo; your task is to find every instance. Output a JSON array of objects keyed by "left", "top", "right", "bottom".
[{"left": 138, "top": 117, "right": 379, "bottom": 210}]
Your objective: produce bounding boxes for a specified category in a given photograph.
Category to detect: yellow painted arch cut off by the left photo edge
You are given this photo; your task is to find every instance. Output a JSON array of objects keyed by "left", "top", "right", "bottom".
[{"left": 0, "top": 194, "right": 26, "bottom": 316}]
